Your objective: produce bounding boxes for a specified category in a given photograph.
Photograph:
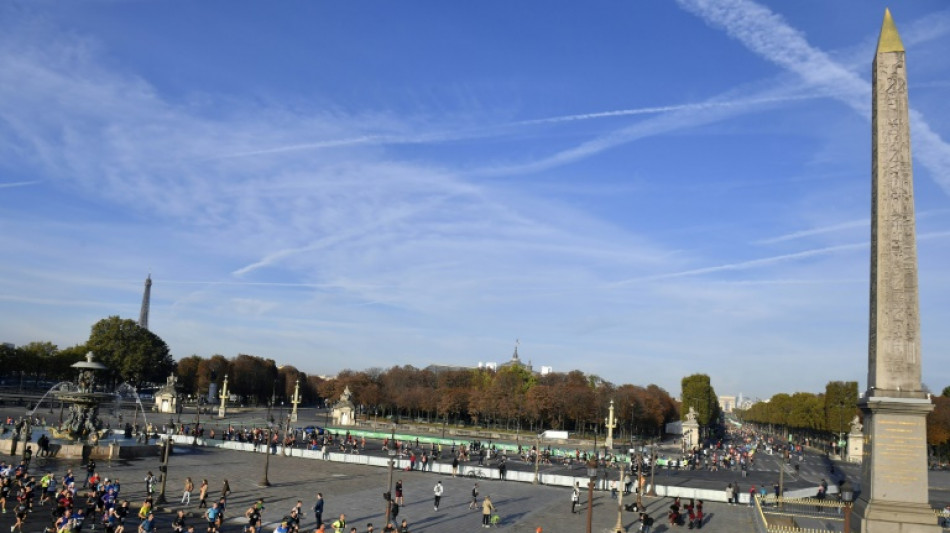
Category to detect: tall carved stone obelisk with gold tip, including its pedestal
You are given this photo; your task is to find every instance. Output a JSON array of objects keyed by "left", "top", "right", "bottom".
[{"left": 852, "top": 11, "right": 941, "bottom": 533}]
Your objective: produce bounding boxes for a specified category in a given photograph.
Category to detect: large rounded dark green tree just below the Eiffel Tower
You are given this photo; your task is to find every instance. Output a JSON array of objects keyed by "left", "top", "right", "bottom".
[{"left": 86, "top": 316, "right": 175, "bottom": 387}]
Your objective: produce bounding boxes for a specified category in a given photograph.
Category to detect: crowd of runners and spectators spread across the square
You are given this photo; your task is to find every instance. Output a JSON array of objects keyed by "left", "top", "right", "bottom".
[{"left": 0, "top": 416, "right": 848, "bottom": 533}]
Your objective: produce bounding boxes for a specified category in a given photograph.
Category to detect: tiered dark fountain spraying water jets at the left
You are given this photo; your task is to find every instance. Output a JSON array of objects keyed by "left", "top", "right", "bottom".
[{"left": 0, "top": 352, "right": 156, "bottom": 459}]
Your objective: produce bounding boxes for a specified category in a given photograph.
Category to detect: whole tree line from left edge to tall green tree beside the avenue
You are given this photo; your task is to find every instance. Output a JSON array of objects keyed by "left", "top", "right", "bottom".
[{"left": 0, "top": 316, "right": 692, "bottom": 439}]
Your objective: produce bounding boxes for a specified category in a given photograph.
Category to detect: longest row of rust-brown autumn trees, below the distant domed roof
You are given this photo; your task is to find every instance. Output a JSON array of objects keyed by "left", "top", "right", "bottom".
[{"left": 319, "top": 364, "right": 679, "bottom": 438}]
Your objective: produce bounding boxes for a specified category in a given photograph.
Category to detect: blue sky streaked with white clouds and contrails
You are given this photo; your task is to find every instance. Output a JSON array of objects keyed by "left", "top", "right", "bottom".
[{"left": 0, "top": 0, "right": 950, "bottom": 397}]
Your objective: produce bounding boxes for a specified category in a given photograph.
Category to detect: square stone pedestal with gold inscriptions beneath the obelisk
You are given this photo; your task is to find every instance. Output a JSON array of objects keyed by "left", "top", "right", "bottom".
[{"left": 852, "top": 397, "right": 941, "bottom": 533}]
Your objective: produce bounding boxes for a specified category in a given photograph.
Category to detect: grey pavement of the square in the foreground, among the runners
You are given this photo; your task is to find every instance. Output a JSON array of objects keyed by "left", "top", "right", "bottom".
[{"left": 0, "top": 446, "right": 753, "bottom": 533}]
